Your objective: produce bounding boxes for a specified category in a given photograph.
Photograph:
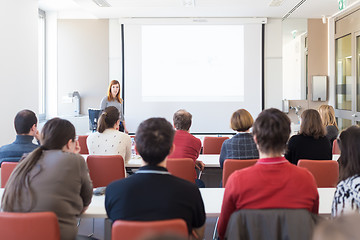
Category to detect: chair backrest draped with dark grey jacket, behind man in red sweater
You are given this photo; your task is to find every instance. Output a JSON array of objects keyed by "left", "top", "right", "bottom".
[{"left": 225, "top": 209, "right": 317, "bottom": 240}]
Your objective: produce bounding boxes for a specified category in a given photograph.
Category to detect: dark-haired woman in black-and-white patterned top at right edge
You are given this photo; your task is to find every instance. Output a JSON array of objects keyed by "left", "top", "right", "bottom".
[{"left": 331, "top": 126, "right": 360, "bottom": 217}]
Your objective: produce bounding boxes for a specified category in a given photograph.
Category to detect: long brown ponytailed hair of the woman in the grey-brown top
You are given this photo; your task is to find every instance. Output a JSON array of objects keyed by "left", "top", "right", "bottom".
[{"left": 1, "top": 118, "right": 75, "bottom": 212}]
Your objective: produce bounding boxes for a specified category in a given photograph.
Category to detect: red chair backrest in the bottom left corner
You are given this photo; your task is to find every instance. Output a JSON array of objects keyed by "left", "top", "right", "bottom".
[{"left": 0, "top": 212, "right": 60, "bottom": 240}]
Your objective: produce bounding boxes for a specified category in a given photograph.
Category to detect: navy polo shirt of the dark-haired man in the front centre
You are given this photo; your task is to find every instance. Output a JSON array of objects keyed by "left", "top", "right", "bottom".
[{"left": 105, "top": 166, "right": 206, "bottom": 233}]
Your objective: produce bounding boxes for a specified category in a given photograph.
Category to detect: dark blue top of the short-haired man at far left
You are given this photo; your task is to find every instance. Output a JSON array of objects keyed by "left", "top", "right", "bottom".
[{"left": 0, "top": 135, "right": 39, "bottom": 164}]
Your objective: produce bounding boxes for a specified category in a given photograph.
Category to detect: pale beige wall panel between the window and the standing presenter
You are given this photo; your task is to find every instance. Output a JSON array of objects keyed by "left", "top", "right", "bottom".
[{"left": 57, "top": 20, "right": 109, "bottom": 116}]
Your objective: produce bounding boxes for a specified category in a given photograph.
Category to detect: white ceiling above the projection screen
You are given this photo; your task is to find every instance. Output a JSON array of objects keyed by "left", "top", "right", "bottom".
[{"left": 38, "top": 0, "right": 356, "bottom": 19}]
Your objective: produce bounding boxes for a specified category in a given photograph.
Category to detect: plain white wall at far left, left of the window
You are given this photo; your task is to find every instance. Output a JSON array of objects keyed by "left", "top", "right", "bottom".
[{"left": 0, "top": 0, "right": 38, "bottom": 145}]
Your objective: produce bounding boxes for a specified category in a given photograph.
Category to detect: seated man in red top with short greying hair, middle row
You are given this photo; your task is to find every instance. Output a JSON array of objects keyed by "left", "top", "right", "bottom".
[{"left": 169, "top": 109, "right": 205, "bottom": 173}]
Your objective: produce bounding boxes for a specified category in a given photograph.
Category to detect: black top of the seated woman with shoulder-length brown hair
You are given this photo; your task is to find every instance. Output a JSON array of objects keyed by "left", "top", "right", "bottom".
[{"left": 285, "top": 134, "right": 332, "bottom": 165}]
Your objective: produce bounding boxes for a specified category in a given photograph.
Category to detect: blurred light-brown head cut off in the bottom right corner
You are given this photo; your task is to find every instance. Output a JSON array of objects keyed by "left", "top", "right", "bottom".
[{"left": 312, "top": 214, "right": 360, "bottom": 240}]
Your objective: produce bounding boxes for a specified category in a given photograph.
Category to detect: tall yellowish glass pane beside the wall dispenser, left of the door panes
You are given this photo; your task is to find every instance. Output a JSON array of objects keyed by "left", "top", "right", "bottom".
[{"left": 335, "top": 34, "right": 352, "bottom": 110}]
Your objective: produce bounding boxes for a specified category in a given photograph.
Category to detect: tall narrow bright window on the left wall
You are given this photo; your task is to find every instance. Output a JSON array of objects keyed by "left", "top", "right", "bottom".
[{"left": 38, "top": 9, "right": 46, "bottom": 120}]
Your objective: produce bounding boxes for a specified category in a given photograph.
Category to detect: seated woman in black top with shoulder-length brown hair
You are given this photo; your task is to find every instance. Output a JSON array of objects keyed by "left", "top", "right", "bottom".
[{"left": 285, "top": 109, "right": 332, "bottom": 165}]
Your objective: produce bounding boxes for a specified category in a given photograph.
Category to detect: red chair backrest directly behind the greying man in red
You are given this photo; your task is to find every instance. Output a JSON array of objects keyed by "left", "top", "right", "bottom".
[{"left": 166, "top": 158, "right": 196, "bottom": 183}]
